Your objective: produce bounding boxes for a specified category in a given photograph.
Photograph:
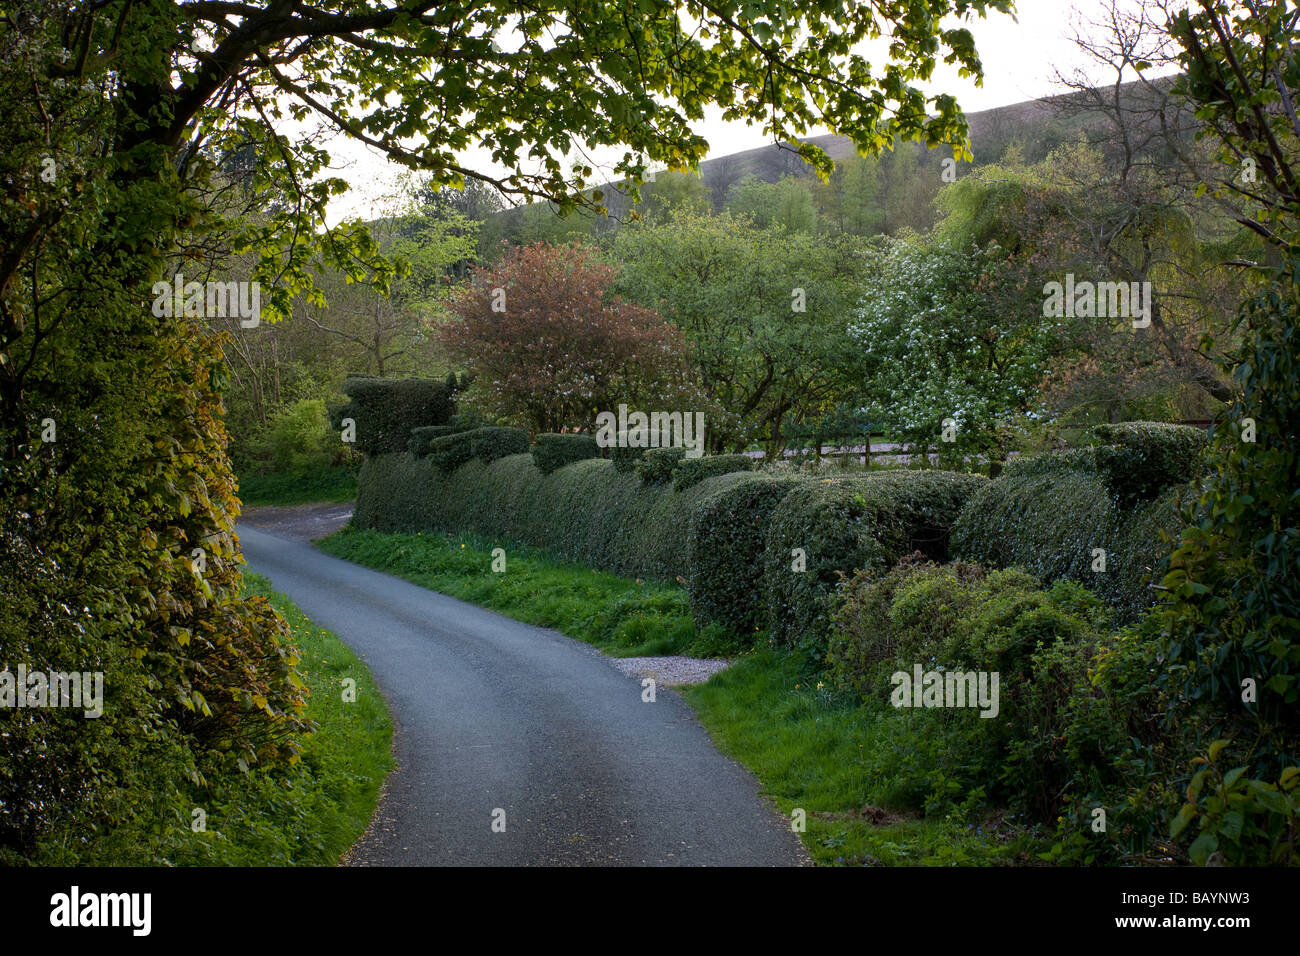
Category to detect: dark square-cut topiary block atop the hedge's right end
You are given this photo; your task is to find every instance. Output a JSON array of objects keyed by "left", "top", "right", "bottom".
[{"left": 1092, "top": 421, "right": 1208, "bottom": 506}]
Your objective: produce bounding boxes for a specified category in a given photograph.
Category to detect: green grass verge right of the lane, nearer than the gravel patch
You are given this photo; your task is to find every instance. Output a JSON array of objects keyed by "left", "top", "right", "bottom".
[{"left": 684, "top": 648, "right": 1045, "bottom": 866}]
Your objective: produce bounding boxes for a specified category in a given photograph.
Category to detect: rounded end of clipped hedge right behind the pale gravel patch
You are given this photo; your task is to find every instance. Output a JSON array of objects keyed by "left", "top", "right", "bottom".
[{"left": 686, "top": 475, "right": 803, "bottom": 635}]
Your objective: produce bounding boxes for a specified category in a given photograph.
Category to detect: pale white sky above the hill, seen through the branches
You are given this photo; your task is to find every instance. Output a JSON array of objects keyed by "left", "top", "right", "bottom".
[{"left": 312, "top": 0, "right": 1180, "bottom": 225}]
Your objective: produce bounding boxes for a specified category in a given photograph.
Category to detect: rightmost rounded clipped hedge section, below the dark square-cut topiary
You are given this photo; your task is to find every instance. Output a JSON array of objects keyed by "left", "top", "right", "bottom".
[{"left": 952, "top": 449, "right": 1180, "bottom": 619}]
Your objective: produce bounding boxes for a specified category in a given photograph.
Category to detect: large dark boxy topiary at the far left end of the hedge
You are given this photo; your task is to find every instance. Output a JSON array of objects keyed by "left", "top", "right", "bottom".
[{"left": 330, "top": 376, "right": 456, "bottom": 455}]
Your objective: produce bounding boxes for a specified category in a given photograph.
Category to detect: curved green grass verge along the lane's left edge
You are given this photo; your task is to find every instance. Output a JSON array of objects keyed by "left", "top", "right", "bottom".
[{"left": 33, "top": 572, "right": 394, "bottom": 866}]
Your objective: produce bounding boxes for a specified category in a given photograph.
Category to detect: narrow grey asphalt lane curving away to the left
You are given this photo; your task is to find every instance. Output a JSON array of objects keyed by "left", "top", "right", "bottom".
[{"left": 238, "top": 525, "right": 807, "bottom": 866}]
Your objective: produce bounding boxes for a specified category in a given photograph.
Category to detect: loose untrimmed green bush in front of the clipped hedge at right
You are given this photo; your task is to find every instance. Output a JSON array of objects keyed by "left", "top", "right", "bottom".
[{"left": 828, "top": 563, "right": 1125, "bottom": 819}]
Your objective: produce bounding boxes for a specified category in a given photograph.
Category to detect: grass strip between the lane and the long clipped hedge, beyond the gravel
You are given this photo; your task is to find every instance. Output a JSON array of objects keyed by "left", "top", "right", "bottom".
[{"left": 319, "top": 527, "right": 740, "bottom": 657}]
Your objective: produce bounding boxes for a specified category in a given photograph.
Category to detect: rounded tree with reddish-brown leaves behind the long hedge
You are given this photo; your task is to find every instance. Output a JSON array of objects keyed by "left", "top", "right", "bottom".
[{"left": 438, "top": 243, "right": 703, "bottom": 433}]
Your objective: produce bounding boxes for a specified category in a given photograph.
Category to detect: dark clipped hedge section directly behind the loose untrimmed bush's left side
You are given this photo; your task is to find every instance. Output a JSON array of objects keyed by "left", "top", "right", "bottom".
[{"left": 763, "top": 471, "right": 988, "bottom": 641}]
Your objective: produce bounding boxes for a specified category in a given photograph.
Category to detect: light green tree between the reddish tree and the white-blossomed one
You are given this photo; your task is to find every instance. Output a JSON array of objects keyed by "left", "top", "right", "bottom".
[{"left": 614, "top": 213, "right": 863, "bottom": 454}]
